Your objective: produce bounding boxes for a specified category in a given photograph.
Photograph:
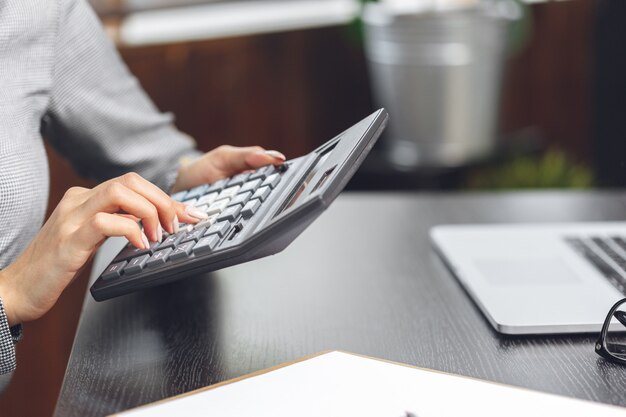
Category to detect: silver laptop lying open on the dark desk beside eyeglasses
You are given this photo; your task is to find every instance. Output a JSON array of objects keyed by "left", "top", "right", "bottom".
[{"left": 430, "top": 222, "right": 626, "bottom": 335}]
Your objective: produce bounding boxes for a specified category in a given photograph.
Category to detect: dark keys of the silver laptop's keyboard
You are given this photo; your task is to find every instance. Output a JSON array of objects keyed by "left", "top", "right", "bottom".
[{"left": 565, "top": 236, "right": 626, "bottom": 294}]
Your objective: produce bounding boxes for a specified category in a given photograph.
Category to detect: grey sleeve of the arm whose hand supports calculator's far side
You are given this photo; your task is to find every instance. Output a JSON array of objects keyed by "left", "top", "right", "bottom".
[{"left": 42, "top": 0, "right": 200, "bottom": 190}]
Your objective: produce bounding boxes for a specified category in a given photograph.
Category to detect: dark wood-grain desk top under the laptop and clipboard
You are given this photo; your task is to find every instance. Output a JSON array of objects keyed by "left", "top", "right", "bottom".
[{"left": 55, "top": 192, "right": 626, "bottom": 417}]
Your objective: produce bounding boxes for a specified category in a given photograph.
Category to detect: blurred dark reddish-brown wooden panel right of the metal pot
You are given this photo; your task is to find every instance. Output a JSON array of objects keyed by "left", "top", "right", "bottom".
[{"left": 501, "top": 0, "right": 597, "bottom": 161}]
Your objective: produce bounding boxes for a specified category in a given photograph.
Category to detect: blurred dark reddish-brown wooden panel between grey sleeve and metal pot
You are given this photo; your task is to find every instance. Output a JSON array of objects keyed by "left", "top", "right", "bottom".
[{"left": 115, "top": 28, "right": 373, "bottom": 157}]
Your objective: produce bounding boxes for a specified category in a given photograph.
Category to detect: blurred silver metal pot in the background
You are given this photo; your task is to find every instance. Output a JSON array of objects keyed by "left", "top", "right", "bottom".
[{"left": 363, "top": 1, "right": 520, "bottom": 169}]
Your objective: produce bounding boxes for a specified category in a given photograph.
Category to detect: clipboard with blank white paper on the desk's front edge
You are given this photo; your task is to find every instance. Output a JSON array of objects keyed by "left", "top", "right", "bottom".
[{"left": 110, "top": 351, "right": 626, "bottom": 417}]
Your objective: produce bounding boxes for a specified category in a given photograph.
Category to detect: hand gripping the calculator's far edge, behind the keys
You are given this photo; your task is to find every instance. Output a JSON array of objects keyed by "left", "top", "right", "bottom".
[{"left": 172, "top": 145, "right": 285, "bottom": 192}]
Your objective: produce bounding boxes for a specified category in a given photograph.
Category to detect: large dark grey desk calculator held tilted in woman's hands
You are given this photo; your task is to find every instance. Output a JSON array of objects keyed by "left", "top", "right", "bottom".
[{"left": 90, "top": 109, "right": 388, "bottom": 301}]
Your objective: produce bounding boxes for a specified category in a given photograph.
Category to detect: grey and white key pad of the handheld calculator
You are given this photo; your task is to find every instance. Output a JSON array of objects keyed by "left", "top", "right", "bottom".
[{"left": 101, "top": 164, "right": 288, "bottom": 280}]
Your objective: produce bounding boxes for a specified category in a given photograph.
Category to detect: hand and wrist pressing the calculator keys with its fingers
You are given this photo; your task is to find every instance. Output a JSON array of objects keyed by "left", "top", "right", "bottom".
[{"left": 0, "top": 173, "right": 198, "bottom": 325}]
